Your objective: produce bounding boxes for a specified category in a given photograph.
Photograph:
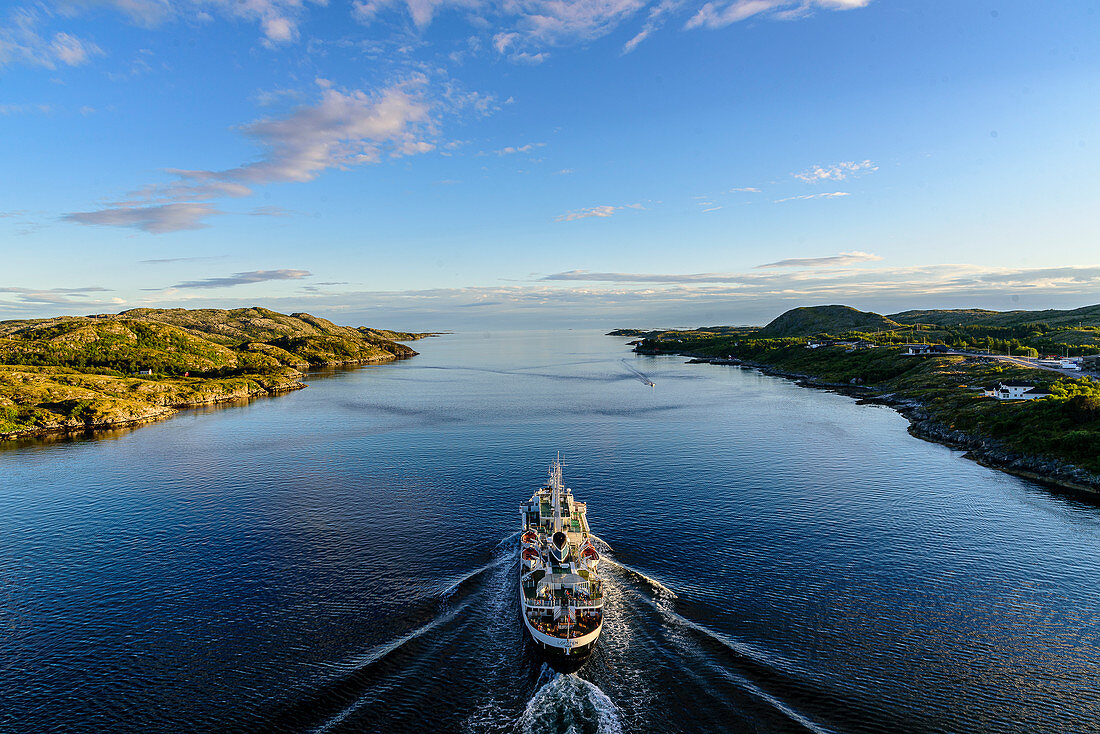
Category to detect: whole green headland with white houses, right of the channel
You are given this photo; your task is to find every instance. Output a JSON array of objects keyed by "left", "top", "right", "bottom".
[{"left": 608, "top": 305, "right": 1100, "bottom": 492}]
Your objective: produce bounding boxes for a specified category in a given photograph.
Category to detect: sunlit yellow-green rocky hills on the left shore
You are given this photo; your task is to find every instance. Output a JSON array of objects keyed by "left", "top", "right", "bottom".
[{"left": 0, "top": 308, "right": 428, "bottom": 438}]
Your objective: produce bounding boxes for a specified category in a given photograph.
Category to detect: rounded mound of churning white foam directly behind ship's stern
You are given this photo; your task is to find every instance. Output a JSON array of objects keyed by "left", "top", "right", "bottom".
[{"left": 519, "top": 667, "right": 623, "bottom": 734}]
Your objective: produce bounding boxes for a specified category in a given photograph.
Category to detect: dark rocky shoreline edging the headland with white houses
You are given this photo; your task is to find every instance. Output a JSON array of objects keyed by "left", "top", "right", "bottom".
[{"left": 666, "top": 352, "right": 1100, "bottom": 495}]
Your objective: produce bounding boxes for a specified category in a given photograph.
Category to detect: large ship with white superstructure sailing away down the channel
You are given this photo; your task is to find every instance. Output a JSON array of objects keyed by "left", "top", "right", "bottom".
[{"left": 519, "top": 459, "right": 604, "bottom": 670}]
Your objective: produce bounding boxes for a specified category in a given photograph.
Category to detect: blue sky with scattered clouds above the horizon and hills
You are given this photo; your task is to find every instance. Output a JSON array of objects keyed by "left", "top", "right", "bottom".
[{"left": 0, "top": 0, "right": 1100, "bottom": 329}]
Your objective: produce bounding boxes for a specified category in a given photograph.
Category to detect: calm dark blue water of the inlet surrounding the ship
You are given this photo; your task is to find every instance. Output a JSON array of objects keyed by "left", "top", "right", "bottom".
[{"left": 0, "top": 331, "right": 1100, "bottom": 732}]
